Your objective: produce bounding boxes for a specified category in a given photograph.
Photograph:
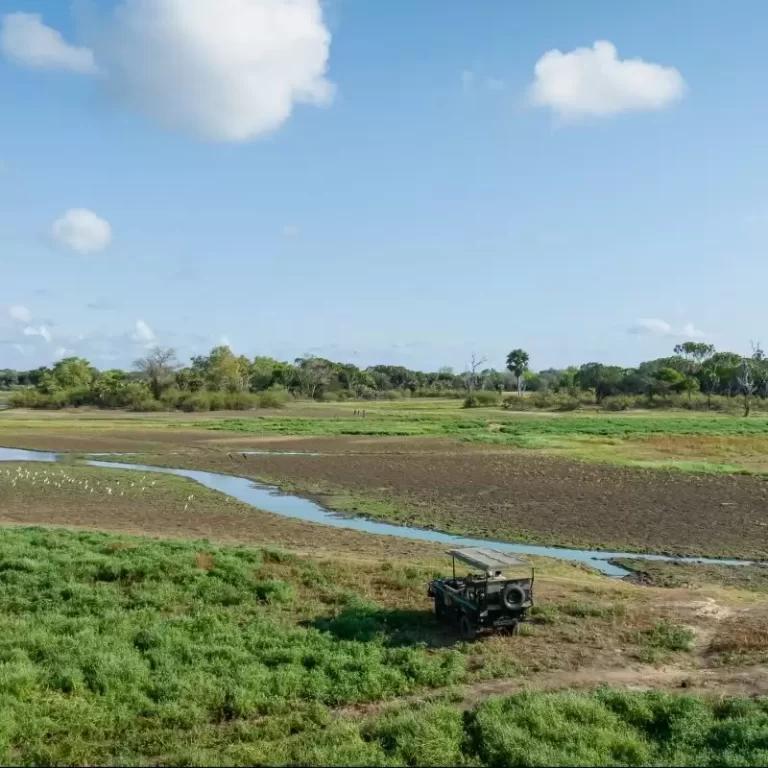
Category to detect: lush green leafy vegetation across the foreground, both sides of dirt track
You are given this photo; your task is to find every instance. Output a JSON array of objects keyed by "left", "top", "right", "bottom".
[{"left": 0, "top": 529, "right": 768, "bottom": 766}]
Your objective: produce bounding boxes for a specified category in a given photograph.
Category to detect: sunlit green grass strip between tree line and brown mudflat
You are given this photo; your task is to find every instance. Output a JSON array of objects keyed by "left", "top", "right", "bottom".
[{"left": 0, "top": 400, "right": 768, "bottom": 473}]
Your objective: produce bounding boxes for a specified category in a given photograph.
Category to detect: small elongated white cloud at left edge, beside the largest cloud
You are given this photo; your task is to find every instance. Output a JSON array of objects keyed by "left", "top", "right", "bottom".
[{"left": 0, "top": 13, "right": 98, "bottom": 75}]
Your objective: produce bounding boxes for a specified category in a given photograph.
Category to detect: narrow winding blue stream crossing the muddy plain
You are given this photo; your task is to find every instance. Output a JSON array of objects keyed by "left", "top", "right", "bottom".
[{"left": 0, "top": 448, "right": 756, "bottom": 577}]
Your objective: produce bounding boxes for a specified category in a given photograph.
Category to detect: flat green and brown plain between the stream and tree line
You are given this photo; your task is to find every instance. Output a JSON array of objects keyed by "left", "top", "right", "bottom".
[{"left": 0, "top": 401, "right": 768, "bottom": 559}]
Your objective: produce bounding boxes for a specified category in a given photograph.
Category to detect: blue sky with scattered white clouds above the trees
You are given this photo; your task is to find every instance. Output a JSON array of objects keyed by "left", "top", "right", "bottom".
[{"left": 0, "top": 0, "right": 768, "bottom": 369}]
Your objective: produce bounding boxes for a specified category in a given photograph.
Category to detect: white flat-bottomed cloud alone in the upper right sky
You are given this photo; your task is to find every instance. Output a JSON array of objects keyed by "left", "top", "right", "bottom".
[{"left": 530, "top": 40, "right": 686, "bottom": 117}]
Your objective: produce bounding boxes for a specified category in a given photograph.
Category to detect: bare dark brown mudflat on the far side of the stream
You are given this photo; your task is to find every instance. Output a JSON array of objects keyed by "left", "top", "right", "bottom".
[{"left": 115, "top": 448, "right": 768, "bottom": 559}]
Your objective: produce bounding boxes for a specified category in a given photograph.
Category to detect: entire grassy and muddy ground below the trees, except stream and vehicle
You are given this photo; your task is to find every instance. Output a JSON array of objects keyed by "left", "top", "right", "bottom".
[{"left": 0, "top": 401, "right": 768, "bottom": 765}]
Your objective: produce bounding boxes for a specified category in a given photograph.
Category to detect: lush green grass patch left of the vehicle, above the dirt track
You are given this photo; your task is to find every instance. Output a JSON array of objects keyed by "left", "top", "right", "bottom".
[{"left": 0, "top": 529, "right": 465, "bottom": 764}]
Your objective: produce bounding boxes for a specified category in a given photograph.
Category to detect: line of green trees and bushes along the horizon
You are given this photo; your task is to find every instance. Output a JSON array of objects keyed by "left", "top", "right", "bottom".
[{"left": 0, "top": 341, "right": 768, "bottom": 413}]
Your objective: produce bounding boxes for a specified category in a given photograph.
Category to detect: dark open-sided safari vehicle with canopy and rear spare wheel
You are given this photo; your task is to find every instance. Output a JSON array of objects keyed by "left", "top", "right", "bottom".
[{"left": 427, "top": 547, "right": 534, "bottom": 640}]
